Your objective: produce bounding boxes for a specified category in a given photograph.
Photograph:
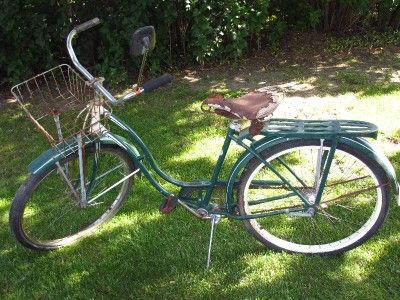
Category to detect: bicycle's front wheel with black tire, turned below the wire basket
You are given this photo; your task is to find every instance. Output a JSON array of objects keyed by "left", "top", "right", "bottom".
[{"left": 9, "top": 145, "right": 135, "bottom": 250}]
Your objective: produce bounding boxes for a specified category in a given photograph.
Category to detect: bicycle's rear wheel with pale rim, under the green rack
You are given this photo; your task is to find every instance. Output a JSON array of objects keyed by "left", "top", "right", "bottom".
[{"left": 238, "top": 140, "right": 389, "bottom": 255}]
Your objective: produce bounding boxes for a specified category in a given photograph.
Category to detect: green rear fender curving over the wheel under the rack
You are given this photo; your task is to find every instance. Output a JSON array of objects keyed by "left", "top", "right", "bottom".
[{"left": 226, "top": 137, "right": 400, "bottom": 209}]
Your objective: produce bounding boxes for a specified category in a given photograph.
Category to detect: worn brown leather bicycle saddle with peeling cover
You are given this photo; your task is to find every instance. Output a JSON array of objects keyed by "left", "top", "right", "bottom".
[{"left": 201, "top": 92, "right": 279, "bottom": 136}]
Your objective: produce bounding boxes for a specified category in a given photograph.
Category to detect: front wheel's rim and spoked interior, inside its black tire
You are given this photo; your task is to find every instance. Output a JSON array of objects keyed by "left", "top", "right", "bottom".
[{"left": 17, "top": 146, "right": 137, "bottom": 248}]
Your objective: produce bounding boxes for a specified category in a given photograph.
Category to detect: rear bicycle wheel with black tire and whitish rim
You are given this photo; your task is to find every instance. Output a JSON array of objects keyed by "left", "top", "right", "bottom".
[{"left": 238, "top": 140, "right": 390, "bottom": 255}]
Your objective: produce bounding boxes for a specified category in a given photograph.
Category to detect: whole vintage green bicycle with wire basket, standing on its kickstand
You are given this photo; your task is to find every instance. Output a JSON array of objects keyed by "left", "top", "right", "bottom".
[{"left": 10, "top": 18, "right": 399, "bottom": 265}]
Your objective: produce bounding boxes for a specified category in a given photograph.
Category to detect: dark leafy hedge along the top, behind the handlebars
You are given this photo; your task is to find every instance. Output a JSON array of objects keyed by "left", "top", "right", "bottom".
[{"left": 0, "top": 0, "right": 400, "bottom": 84}]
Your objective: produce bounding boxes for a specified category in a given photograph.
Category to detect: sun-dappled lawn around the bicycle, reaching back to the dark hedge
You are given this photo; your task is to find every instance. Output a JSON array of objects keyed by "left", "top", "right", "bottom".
[{"left": 0, "top": 38, "right": 400, "bottom": 299}]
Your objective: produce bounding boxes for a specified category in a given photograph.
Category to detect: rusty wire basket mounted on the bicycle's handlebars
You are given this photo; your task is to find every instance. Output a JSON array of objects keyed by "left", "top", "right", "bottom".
[{"left": 11, "top": 65, "right": 105, "bottom": 155}]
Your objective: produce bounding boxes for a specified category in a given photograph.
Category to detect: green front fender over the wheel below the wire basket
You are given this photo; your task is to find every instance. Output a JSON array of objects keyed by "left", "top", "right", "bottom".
[{"left": 28, "top": 133, "right": 139, "bottom": 174}]
